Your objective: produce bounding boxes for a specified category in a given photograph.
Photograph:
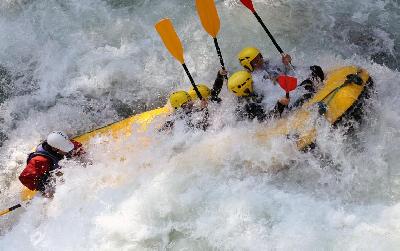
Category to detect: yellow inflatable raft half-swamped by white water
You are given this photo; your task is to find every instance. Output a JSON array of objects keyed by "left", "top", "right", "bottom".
[{"left": 15, "top": 66, "right": 372, "bottom": 204}]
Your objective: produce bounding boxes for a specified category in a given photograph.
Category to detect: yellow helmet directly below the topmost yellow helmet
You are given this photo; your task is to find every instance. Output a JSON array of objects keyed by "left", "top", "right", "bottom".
[{"left": 228, "top": 71, "right": 253, "bottom": 97}]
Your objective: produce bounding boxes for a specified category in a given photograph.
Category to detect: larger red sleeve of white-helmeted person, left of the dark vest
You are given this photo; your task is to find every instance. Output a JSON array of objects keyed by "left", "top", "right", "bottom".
[{"left": 19, "top": 156, "right": 51, "bottom": 191}]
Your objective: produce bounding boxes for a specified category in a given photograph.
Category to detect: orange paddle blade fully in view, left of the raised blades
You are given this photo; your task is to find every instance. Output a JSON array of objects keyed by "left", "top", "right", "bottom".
[{"left": 155, "top": 18, "right": 185, "bottom": 64}]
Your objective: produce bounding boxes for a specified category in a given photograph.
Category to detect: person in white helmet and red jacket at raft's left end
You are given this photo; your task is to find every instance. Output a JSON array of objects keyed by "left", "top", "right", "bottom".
[{"left": 19, "top": 131, "right": 84, "bottom": 197}]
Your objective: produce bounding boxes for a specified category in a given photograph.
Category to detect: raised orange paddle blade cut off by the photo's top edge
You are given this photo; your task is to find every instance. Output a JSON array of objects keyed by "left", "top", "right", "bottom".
[{"left": 196, "top": 0, "right": 220, "bottom": 38}]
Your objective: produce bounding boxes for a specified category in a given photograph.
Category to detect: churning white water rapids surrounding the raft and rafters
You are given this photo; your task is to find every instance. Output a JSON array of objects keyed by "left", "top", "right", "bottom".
[{"left": 0, "top": 0, "right": 400, "bottom": 250}]
